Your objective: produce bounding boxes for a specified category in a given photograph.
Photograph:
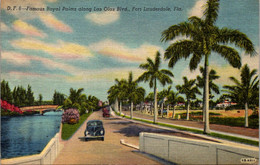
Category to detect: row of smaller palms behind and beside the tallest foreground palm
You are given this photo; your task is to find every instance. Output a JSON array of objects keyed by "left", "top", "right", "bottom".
[{"left": 108, "top": 53, "right": 259, "bottom": 132}]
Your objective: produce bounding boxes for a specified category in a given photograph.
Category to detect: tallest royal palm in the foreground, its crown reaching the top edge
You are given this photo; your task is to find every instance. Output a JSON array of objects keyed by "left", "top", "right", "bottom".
[{"left": 161, "top": 0, "right": 256, "bottom": 133}]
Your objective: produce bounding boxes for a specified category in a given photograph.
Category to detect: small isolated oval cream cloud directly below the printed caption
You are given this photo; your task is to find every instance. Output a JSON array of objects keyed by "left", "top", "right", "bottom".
[{"left": 86, "top": 11, "right": 120, "bottom": 25}]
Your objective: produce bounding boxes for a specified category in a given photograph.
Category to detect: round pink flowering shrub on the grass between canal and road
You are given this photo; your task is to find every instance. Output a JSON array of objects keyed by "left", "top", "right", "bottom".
[{"left": 62, "top": 108, "right": 79, "bottom": 124}]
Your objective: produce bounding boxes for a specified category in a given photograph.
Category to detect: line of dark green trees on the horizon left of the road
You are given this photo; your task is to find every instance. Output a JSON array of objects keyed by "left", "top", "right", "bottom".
[{"left": 1, "top": 80, "right": 99, "bottom": 115}]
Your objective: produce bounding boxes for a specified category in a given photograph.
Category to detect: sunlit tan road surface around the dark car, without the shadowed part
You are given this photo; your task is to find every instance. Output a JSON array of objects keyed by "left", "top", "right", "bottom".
[{"left": 54, "top": 111, "right": 164, "bottom": 165}]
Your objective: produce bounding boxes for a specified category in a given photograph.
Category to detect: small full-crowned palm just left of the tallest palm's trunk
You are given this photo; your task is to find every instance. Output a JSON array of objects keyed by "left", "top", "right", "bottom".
[{"left": 176, "top": 77, "right": 201, "bottom": 120}]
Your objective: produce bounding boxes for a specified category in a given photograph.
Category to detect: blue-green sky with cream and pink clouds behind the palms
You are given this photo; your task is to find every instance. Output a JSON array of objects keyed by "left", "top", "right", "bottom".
[{"left": 1, "top": 0, "right": 259, "bottom": 100}]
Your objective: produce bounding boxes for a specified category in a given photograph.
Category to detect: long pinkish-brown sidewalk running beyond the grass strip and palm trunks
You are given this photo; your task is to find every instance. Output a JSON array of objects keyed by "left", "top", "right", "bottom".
[{"left": 119, "top": 111, "right": 259, "bottom": 141}]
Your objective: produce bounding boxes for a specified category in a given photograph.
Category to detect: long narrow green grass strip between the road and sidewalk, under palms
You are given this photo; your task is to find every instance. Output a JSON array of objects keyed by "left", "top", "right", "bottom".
[{"left": 115, "top": 112, "right": 259, "bottom": 146}]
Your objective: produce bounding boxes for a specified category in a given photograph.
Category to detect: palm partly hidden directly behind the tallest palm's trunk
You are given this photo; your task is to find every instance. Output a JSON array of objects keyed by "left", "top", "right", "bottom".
[{"left": 196, "top": 67, "right": 219, "bottom": 122}]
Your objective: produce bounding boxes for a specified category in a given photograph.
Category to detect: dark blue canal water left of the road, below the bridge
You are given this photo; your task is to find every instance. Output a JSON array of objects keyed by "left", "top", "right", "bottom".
[{"left": 1, "top": 112, "right": 62, "bottom": 159}]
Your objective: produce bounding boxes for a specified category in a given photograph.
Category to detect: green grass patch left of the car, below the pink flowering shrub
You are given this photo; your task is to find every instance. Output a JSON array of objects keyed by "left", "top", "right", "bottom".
[{"left": 61, "top": 112, "right": 92, "bottom": 140}]
